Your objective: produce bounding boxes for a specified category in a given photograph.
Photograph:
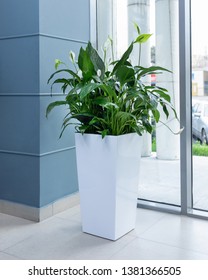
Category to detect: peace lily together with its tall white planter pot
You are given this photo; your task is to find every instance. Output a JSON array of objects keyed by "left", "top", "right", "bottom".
[{"left": 46, "top": 25, "right": 182, "bottom": 240}]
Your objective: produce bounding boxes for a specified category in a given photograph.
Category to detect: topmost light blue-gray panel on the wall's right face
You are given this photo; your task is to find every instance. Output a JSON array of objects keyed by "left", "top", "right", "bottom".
[{"left": 39, "top": 0, "right": 90, "bottom": 42}]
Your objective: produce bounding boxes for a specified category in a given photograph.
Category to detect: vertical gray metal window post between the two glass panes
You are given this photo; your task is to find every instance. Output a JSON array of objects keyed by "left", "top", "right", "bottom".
[{"left": 179, "top": 0, "right": 193, "bottom": 215}]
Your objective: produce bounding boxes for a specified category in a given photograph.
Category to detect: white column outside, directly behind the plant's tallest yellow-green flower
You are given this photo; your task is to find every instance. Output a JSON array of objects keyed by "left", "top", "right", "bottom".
[{"left": 127, "top": 0, "right": 152, "bottom": 157}]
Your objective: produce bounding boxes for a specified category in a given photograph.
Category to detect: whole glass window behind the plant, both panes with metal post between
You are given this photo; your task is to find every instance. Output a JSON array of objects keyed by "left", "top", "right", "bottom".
[{"left": 92, "top": 0, "right": 208, "bottom": 218}]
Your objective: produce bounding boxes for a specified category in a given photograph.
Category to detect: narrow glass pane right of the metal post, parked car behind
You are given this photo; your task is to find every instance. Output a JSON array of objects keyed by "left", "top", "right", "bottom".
[{"left": 191, "top": 0, "right": 208, "bottom": 211}]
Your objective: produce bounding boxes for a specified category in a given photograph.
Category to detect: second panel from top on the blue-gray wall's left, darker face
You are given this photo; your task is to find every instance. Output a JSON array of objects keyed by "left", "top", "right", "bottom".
[{"left": 0, "top": 36, "right": 39, "bottom": 95}]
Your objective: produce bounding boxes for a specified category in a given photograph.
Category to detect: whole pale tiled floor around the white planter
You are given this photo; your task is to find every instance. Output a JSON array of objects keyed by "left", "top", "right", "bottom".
[{"left": 0, "top": 206, "right": 208, "bottom": 260}]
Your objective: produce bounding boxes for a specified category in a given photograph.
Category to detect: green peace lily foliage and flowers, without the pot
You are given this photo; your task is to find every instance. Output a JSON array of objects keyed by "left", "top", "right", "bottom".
[{"left": 46, "top": 25, "right": 177, "bottom": 138}]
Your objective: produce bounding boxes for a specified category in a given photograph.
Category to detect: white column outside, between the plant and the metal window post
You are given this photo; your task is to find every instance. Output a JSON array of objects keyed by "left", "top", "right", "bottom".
[{"left": 155, "top": 0, "right": 180, "bottom": 160}]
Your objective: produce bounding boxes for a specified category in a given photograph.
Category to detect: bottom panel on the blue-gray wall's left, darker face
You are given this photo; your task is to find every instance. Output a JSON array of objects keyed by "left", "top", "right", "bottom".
[{"left": 0, "top": 152, "right": 40, "bottom": 207}]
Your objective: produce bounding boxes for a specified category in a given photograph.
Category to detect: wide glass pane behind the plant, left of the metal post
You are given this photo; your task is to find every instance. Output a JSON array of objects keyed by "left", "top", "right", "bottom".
[{"left": 97, "top": 0, "right": 181, "bottom": 205}]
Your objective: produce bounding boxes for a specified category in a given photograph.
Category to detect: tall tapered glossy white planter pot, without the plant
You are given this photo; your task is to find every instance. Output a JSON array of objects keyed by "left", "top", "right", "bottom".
[{"left": 75, "top": 133, "right": 142, "bottom": 240}]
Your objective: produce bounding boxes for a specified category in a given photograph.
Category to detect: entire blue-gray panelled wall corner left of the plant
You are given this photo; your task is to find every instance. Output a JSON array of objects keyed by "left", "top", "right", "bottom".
[{"left": 0, "top": 0, "right": 90, "bottom": 208}]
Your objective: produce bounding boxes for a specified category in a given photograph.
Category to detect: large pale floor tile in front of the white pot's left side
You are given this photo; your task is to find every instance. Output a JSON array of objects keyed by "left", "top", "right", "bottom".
[{"left": 5, "top": 221, "right": 134, "bottom": 259}]
